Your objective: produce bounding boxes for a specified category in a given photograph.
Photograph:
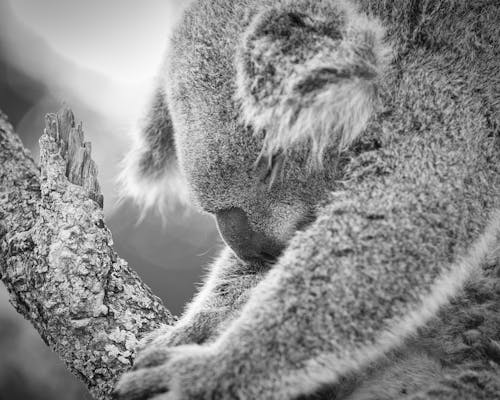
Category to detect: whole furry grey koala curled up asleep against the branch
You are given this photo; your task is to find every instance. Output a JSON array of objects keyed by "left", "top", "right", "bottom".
[{"left": 115, "top": 0, "right": 500, "bottom": 400}]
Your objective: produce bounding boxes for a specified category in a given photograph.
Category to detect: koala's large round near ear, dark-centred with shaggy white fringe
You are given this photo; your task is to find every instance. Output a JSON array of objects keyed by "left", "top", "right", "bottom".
[{"left": 236, "top": 1, "right": 391, "bottom": 166}]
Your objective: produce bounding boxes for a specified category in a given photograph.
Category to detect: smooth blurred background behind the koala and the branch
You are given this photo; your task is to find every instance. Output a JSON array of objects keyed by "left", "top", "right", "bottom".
[{"left": 0, "top": 0, "right": 220, "bottom": 400}]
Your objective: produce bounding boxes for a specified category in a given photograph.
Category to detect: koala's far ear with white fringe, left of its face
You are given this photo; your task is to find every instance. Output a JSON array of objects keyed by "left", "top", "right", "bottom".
[{"left": 118, "top": 82, "right": 189, "bottom": 216}]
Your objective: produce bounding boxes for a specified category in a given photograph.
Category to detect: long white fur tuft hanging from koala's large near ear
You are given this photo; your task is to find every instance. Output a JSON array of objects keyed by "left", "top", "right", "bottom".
[{"left": 243, "top": 71, "right": 374, "bottom": 165}]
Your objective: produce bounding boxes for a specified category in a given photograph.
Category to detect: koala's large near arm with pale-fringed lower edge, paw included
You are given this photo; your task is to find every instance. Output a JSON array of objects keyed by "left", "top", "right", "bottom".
[{"left": 114, "top": 128, "right": 500, "bottom": 399}]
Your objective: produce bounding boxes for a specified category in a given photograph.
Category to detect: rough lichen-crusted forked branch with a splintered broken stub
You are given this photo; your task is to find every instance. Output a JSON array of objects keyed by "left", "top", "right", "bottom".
[{"left": 0, "top": 109, "right": 174, "bottom": 399}]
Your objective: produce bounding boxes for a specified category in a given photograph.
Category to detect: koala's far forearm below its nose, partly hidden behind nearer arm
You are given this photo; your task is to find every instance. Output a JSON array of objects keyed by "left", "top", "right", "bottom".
[{"left": 134, "top": 248, "right": 264, "bottom": 367}]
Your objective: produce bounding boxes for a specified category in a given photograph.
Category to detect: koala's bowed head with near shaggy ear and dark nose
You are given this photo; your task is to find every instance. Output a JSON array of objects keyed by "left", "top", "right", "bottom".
[{"left": 124, "top": 1, "right": 390, "bottom": 264}]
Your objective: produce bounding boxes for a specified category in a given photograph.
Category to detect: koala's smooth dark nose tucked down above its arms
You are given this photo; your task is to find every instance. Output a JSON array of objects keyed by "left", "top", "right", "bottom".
[{"left": 215, "top": 207, "right": 284, "bottom": 264}]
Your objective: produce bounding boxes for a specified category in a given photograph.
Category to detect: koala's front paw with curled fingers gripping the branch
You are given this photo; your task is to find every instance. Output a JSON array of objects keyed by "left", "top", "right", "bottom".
[{"left": 114, "top": 345, "right": 227, "bottom": 400}]
